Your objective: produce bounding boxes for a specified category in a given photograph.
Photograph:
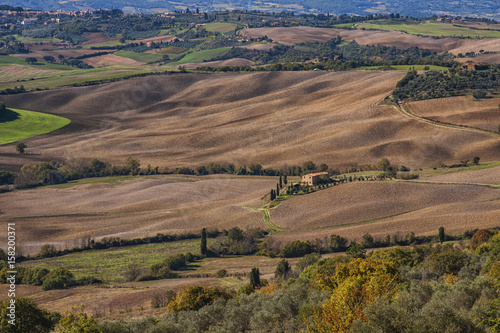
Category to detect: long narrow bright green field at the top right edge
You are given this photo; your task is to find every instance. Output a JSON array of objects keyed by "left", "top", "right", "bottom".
[{"left": 348, "top": 21, "right": 500, "bottom": 38}]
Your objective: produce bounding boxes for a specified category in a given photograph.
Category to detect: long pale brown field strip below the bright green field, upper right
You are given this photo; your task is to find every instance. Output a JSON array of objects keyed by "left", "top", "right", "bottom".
[{"left": 241, "top": 27, "right": 500, "bottom": 54}]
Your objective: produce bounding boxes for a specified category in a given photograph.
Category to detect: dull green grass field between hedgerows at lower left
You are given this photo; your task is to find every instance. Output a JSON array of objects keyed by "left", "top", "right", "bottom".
[{"left": 22, "top": 239, "right": 200, "bottom": 283}]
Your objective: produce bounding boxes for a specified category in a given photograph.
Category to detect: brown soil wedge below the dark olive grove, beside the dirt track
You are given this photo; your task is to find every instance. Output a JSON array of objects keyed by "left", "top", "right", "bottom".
[{"left": 407, "top": 97, "right": 500, "bottom": 131}]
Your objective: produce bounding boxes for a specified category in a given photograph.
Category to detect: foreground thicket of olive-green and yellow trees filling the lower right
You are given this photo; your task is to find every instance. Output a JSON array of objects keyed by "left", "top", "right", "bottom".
[{"left": 96, "top": 231, "right": 500, "bottom": 333}]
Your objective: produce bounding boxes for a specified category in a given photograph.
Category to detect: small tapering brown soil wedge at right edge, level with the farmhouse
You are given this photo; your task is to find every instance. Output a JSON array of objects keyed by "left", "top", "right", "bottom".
[{"left": 421, "top": 167, "right": 500, "bottom": 185}]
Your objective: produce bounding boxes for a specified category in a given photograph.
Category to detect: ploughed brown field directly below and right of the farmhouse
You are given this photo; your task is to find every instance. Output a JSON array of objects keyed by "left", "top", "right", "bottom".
[{"left": 271, "top": 178, "right": 500, "bottom": 242}]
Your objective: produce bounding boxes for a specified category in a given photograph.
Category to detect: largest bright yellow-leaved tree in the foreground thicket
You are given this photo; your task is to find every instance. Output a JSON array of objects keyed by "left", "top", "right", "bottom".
[{"left": 308, "top": 258, "right": 400, "bottom": 333}]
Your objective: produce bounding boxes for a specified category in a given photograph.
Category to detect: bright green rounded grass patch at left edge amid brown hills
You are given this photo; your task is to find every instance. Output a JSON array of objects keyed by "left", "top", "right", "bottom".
[{"left": 0, "top": 109, "right": 70, "bottom": 145}]
